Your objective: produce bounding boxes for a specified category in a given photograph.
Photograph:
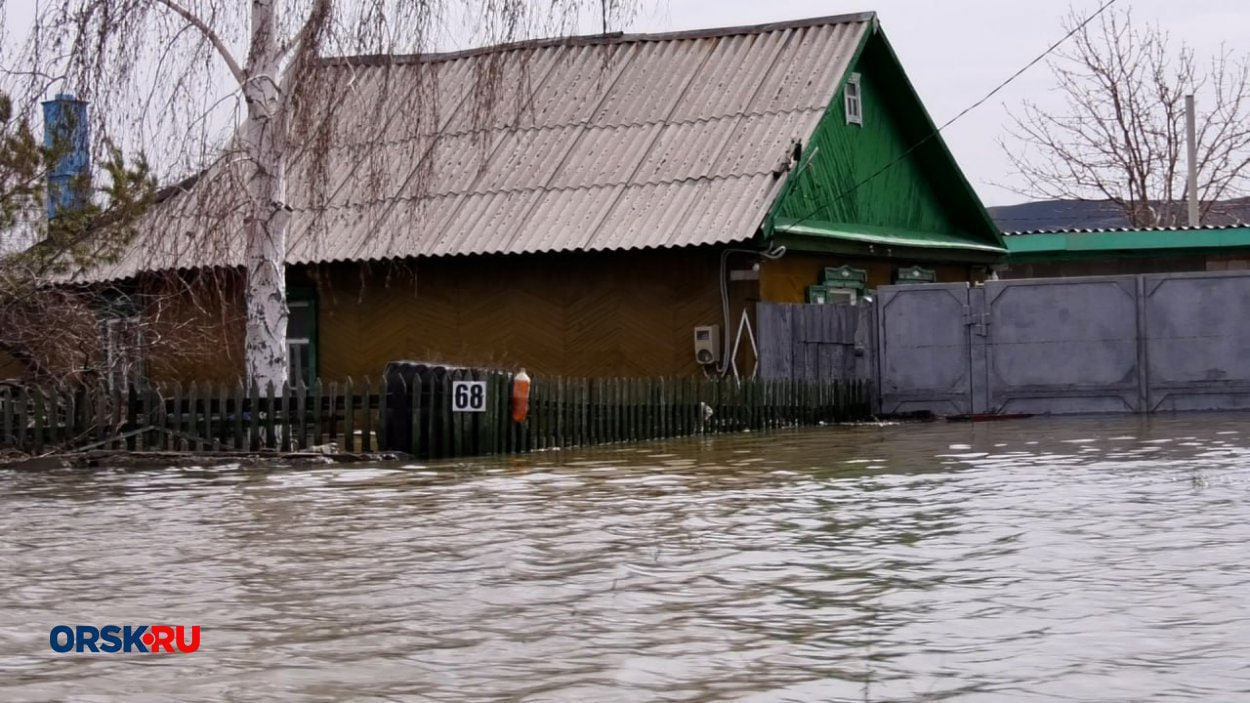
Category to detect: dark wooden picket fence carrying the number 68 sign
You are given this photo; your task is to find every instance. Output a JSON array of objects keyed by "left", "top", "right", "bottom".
[{"left": 0, "top": 369, "right": 871, "bottom": 459}]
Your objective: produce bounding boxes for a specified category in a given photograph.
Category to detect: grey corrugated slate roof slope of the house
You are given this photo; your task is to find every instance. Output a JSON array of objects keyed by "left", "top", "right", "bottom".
[{"left": 75, "top": 14, "right": 875, "bottom": 279}]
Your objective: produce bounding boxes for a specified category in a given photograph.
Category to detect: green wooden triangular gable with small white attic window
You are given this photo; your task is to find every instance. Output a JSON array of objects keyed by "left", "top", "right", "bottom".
[{"left": 763, "top": 28, "right": 1006, "bottom": 261}]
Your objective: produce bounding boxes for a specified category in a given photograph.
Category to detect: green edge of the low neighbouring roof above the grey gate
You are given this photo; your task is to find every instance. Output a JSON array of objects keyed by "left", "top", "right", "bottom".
[{"left": 1006, "top": 225, "right": 1250, "bottom": 259}]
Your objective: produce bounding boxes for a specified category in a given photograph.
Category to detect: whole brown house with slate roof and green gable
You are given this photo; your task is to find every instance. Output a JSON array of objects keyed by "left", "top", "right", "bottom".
[{"left": 0, "top": 13, "right": 1005, "bottom": 383}]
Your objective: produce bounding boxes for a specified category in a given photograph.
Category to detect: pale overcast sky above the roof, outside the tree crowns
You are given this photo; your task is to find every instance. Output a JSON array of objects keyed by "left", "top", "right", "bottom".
[{"left": 8, "top": 0, "right": 1250, "bottom": 205}]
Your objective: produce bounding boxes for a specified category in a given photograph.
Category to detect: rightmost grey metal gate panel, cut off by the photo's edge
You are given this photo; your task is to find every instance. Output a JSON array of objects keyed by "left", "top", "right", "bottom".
[{"left": 1141, "top": 271, "right": 1250, "bottom": 412}]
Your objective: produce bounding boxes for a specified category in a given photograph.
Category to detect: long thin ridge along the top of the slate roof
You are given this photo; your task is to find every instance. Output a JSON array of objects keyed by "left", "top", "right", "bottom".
[{"left": 320, "top": 11, "right": 876, "bottom": 66}]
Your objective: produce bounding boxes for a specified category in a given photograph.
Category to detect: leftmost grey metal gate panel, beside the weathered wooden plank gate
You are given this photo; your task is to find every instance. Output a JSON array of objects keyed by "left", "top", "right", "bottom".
[{"left": 876, "top": 283, "right": 971, "bottom": 415}]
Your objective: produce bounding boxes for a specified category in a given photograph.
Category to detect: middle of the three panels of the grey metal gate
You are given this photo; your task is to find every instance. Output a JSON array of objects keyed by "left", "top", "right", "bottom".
[{"left": 974, "top": 275, "right": 1143, "bottom": 414}]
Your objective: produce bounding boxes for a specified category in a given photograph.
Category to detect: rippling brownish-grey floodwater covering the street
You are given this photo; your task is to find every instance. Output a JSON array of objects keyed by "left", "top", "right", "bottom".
[{"left": 0, "top": 415, "right": 1250, "bottom": 702}]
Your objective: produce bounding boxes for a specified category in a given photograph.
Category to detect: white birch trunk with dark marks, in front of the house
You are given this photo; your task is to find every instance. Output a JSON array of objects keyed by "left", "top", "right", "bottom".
[{"left": 241, "top": 0, "right": 290, "bottom": 388}]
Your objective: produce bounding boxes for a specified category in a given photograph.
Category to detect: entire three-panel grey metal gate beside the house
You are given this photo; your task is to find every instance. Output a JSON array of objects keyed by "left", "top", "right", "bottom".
[{"left": 878, "top": 273, "right": 1250, "bottom": 415}]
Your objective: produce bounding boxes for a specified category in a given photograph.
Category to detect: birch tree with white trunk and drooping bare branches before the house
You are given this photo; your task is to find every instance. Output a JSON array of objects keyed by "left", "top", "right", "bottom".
[{"left": 0, "top": 0, "right": 631, "bottom": 384}]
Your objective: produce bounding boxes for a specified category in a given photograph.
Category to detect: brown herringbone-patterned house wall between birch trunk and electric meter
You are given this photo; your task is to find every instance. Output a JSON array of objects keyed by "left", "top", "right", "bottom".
[{"left": 311, "top": 250, "right": 755, "bottom": 379}]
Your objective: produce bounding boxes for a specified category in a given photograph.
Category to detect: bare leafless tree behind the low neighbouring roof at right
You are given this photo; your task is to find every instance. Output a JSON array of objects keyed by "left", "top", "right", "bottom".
[{"left": 1003, "top": 10, "right": 1250, "bottom": 226}]
